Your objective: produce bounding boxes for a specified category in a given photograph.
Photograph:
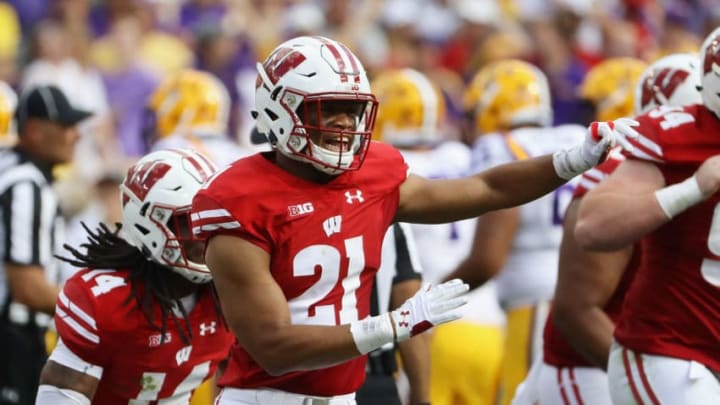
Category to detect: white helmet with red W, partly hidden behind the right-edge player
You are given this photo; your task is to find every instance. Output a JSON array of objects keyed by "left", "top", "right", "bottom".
[{"left": 635, "top": 53, "right": 702, "bottom": 115}]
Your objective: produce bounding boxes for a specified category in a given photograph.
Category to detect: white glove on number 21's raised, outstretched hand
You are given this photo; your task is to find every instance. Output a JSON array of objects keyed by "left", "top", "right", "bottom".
[{"left": 553, "top": 118, "right": 640, "bottom": 180}]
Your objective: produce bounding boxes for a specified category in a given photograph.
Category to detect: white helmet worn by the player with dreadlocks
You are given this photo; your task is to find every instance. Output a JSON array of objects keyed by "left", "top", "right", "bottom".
[{"left": 120, "top": 149, "right": 216, "bottom": 283}]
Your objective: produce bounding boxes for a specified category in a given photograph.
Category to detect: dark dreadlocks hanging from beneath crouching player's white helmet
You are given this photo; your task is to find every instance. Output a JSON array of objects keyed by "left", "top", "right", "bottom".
[{"left": 55, "top": 222, "right": 227, "bottom": 344}]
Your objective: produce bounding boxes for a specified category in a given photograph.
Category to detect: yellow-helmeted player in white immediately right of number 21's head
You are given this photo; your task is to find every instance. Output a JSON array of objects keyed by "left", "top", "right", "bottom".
[{"left": 371, "top": 69, "right": 504, "bottom": 405}]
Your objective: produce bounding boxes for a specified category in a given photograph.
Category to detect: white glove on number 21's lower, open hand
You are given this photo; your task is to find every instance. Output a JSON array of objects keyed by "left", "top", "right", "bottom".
[{"left": 390, "top": 279, "right": 470, "bottom": 342}]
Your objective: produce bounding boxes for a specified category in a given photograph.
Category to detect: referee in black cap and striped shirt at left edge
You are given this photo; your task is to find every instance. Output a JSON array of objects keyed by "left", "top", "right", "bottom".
[{"left": 0, "top": 85, "right": 90, "bottom": 404}]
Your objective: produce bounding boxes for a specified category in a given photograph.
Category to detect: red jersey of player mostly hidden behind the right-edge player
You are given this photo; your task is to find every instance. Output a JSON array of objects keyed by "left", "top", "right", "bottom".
[{"left": 543, "top": 153, "right": 640, "bottom": 367}]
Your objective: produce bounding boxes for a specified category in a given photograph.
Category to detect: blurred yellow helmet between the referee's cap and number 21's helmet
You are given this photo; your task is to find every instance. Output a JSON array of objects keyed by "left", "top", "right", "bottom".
[{"left": 148, "top": 69, "right": 230, "bottom": 139}]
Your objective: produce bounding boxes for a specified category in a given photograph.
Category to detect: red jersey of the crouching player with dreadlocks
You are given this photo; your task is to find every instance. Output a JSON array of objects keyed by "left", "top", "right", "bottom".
[{"left": 55, "top": 269, "right": 233, "bottom": 405}]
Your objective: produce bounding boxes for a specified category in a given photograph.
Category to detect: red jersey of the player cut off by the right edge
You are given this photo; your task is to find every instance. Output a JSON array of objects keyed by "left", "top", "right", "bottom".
[{"left": 615, "top": 105, "right": 720, "bottom": 371}]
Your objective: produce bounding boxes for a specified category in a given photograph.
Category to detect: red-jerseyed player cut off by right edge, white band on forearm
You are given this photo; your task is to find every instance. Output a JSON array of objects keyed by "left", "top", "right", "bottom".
[{"left": 575, "top": 28, "right": 720, "bottom": 405}]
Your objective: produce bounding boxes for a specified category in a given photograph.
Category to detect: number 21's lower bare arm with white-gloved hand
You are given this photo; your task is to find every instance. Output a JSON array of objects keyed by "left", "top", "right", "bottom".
[{"left": 206, "top": 235, "right": 467, "bottom": 374}]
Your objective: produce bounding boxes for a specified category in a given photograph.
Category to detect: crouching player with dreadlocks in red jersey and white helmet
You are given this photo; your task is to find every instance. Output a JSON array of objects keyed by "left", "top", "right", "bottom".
[{"left": 36, "top": 149, "right": 233, "bottom": 405}]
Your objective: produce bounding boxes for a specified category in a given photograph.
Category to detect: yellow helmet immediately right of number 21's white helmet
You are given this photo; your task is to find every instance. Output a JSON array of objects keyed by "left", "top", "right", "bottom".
[{"left": 370, "top": 69, "right": 446, "bottom": 147}]
